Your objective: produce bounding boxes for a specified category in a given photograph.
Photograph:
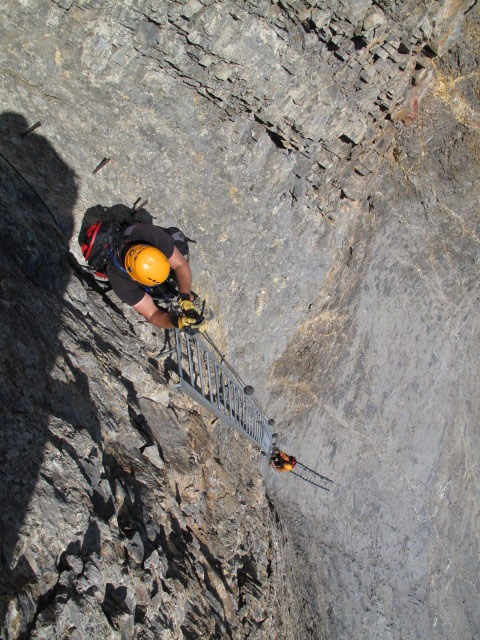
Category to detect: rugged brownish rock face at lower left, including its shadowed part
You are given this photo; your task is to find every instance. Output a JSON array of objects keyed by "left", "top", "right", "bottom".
[{"left": 1, "top": 149, "right": 295, "bottom": 639}]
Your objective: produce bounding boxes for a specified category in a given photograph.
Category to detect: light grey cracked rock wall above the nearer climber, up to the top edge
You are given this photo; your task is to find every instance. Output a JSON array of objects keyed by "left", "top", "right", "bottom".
[{"left": 2, "top": 0, "right": 471, "bottom": 380}]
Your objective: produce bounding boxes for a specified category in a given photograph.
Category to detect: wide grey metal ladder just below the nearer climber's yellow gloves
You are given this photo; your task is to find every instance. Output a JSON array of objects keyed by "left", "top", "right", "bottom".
[{"left": 169, "top": 329, "right": 274, "bottom": 457}]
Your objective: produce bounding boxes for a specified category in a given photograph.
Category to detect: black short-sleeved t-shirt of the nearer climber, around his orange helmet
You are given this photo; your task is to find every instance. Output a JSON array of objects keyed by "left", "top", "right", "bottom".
[{"left": 107, "top": 222, "right": 174, "bottom": 306}]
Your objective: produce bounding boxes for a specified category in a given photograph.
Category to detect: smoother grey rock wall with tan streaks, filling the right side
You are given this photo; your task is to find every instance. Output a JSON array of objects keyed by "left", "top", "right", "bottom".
[{"left": 271, "top": 13, "right": 480, "bottom": 640}]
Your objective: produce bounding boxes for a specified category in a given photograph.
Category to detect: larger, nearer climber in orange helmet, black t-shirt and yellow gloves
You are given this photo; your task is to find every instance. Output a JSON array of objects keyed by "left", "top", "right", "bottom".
[{"left": 80, "top": 222, "right": 205, "bottom": 332}]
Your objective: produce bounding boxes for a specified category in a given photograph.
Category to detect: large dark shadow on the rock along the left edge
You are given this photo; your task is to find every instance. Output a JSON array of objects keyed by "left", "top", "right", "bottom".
[{"left": 0, "top": 113, "right": 79, "bottom": 617}]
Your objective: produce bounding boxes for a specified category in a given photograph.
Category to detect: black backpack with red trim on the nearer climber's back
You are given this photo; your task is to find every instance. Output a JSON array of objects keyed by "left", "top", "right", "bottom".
[{"left": 81, "top": 222, "right": 129, "bottom": 278}]
